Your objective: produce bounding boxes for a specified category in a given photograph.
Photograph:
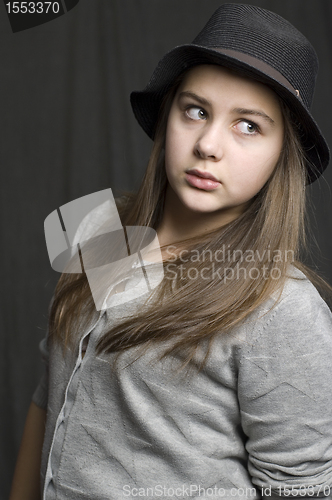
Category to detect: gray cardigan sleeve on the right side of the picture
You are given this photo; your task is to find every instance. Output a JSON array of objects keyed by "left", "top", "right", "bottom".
[{"left": 238, "top": 280, "right": 332, "bottom": 499}]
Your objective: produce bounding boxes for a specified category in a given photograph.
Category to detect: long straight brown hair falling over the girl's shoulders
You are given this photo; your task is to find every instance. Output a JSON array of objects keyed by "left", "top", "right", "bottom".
[{"left": 50, "top": 73, "right": 330, "bottom": 366}]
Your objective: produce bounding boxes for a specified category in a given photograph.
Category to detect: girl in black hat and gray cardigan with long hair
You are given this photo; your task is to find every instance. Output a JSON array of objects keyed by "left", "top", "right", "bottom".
[{"left": 11, "top": 4, "right": 332, "bottom": 500}]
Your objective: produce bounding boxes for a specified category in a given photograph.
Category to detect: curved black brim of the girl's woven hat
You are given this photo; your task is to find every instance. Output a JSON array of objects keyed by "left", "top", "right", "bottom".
[{"left": 130, "top": 44, "right": 330, "bottom": 184}]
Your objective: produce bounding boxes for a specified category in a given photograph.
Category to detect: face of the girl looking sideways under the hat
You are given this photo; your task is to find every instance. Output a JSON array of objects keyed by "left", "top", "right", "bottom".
[{"left": 165, "top": 65, "right": 284, "bottom": 223}]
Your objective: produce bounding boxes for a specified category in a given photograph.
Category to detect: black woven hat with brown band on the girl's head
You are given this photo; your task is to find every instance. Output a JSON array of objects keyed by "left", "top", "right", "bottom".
[{"left": 130, "top": 4, "right": 329, "bottom": 183}]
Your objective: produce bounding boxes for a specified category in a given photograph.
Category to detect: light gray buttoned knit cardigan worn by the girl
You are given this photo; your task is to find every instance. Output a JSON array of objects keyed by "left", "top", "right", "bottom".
[{"left": 33, "top": 272, "right": 332, "bottom": 500}]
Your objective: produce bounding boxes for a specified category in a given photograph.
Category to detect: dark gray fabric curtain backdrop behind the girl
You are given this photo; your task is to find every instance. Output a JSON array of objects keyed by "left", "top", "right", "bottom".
[{"left": 0, "top": 0, "right": 332, "bottom": 500}]
